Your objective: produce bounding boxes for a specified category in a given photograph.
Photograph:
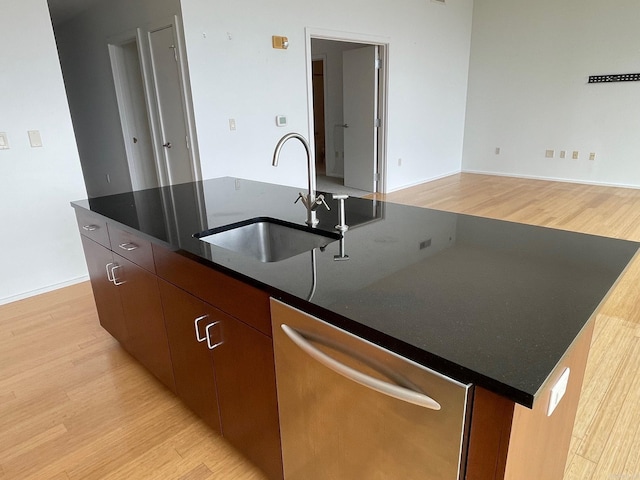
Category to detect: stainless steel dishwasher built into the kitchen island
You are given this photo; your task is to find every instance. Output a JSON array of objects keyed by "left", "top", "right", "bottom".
[{"left": 271, "top": 299, "right": 472, "bottom": 480}]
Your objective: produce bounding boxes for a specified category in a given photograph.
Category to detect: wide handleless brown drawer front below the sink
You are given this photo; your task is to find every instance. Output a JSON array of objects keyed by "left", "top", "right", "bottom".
[{"left": 153, "top": 244, "right": 271, "bottom": 337}]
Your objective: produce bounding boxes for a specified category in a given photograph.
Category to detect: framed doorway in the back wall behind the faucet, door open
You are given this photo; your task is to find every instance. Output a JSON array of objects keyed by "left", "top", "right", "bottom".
[{"left": 307, "top": 29, "right": 387, "bottom": 196}]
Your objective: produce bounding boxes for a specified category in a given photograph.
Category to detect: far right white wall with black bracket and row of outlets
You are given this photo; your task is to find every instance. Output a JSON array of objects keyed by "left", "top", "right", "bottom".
[{"left": 463, "top": 0, "right": 640, "bottom": 186}]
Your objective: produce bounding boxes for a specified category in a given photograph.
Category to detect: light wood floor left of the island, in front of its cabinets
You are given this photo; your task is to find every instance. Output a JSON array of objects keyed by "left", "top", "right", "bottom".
[{"left": 0, "top": 282, "right": 265, "bottom": 480}]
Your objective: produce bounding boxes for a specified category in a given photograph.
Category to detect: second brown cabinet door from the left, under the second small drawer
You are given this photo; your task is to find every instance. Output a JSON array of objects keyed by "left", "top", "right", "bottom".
[{"left": 113, "top": 253, "right": 175, "bottom": 392}]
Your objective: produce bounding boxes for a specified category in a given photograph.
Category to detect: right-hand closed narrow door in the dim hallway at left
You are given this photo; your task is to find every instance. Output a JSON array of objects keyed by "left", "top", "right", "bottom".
[{"left": 149, "top": 25, "right": 195, "bottom": 185}]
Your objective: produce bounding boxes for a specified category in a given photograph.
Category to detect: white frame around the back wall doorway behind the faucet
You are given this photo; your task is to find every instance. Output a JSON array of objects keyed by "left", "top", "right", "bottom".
[{"left": 304, "top": 27, "right": 390, "bottom": 193}]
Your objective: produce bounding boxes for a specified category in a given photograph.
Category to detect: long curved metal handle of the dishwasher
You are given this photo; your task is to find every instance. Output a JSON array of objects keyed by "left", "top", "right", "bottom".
[{"left": 280, "top": 323, "right": 442, "bottom": 410}]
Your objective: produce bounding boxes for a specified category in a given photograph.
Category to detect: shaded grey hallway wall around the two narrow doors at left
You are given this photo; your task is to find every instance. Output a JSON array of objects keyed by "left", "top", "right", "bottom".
[{"left": 56, "top": 0, "right": 180, "bottom": 197}]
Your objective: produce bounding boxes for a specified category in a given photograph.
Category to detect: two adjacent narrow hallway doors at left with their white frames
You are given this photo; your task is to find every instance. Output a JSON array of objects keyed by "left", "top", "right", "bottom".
[{"left": 109, "top": 18, "right": 201, "bottom": 190}]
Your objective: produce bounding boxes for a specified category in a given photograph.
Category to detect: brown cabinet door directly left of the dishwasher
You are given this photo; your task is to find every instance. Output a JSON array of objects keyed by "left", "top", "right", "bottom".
[{"left": 213, "top": 316, "right": 282, "bottom": 479}]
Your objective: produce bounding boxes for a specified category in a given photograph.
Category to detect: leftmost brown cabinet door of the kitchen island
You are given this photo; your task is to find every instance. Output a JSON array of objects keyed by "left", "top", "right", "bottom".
[{"left": 80, "top": 235, "right": 127, "bottom": 346}]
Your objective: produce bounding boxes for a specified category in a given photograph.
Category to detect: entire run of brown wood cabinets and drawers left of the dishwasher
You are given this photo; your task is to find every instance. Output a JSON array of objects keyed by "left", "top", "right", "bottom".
[{"left": 76, "top": 210, "right": 283, "bottom": 479}]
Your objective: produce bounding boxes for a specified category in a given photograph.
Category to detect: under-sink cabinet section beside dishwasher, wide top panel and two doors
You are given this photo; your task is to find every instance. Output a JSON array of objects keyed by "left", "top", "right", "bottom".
[{"left": 153, "top": 245, "right": 283, "bottom": 479}]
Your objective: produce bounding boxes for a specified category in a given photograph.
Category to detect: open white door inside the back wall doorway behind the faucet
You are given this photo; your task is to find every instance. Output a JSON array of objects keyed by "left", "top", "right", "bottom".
[{"left": 342, "top": 46, "right": 378, "bottom": 192}]
